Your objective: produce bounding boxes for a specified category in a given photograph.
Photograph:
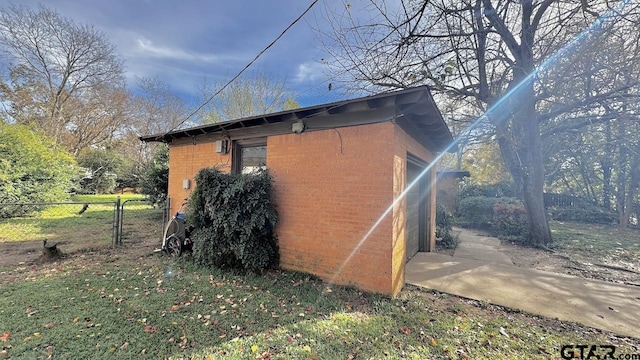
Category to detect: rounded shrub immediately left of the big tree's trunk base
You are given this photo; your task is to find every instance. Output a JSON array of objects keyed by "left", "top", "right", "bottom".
[{"left": 493, "top": 198, "right": 529, "bottom": 238}]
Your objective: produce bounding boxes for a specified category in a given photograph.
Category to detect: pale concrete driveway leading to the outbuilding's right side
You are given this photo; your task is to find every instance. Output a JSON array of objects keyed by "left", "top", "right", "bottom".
[{"left": 405, "top": 230, "right": 640, "bottom": 338}]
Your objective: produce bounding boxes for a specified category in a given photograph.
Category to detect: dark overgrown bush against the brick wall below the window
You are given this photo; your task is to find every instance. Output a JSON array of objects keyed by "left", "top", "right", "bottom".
[{"left": 189, "top": 168, "right": 279, "bottom": 270}]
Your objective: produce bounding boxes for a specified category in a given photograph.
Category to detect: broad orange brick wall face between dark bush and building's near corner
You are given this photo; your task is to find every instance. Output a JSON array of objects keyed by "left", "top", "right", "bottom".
[{"left": 267, "top": 123, "right": 395, "bottom": 295}]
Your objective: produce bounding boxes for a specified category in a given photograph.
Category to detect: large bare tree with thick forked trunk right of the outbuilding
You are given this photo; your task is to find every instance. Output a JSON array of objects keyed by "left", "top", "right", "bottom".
[{"left": 320, "top": 0, "right": 637, "bottom": 247}]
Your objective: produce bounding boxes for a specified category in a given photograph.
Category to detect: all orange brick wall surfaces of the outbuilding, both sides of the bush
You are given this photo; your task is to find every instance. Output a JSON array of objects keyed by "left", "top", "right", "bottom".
[{"left": 169, "top": 122, "right": 435, "bottom": 296}]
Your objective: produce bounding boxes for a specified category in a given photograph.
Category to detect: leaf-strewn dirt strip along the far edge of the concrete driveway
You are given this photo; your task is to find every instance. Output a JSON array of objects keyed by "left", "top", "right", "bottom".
[{"left": 502, "top": 241, "right": 640, "bottom": 286}]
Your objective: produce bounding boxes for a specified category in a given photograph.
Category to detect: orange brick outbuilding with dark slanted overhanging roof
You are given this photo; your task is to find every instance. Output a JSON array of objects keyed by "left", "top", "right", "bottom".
[{"left": 141, "top": 87, "right": 452, "bottom": 296}]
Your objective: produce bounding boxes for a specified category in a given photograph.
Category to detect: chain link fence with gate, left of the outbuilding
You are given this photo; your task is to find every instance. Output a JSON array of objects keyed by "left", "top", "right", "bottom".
[{"left": 0, "top": 198, "right": 168, "bottom": 266}]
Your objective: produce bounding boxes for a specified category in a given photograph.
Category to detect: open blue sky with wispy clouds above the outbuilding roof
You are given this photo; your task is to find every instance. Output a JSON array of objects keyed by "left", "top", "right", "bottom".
[{"left": 5, "top": 0, "right": 356, "bottom": 106}]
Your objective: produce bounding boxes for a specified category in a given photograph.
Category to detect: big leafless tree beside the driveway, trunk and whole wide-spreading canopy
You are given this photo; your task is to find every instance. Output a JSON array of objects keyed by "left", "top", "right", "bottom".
[{"left": 320, "top": 0, "right": 640, "bottom": 246}]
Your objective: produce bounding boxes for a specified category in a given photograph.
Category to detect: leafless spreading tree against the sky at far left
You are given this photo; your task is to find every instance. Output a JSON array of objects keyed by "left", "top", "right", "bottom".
[{"left": 0, "top": 6, "right": 124, "bottom": 147}]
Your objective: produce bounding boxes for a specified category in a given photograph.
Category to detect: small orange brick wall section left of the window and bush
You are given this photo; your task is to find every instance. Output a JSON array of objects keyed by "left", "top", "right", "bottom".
[{"left": 169, "top": 139, "right": 231, "bottom": 214}]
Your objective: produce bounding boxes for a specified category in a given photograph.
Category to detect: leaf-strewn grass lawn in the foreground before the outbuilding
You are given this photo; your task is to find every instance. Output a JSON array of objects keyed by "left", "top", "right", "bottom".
[{"left": 0, "top": 251, "right": 639, "bottom": 359}]
